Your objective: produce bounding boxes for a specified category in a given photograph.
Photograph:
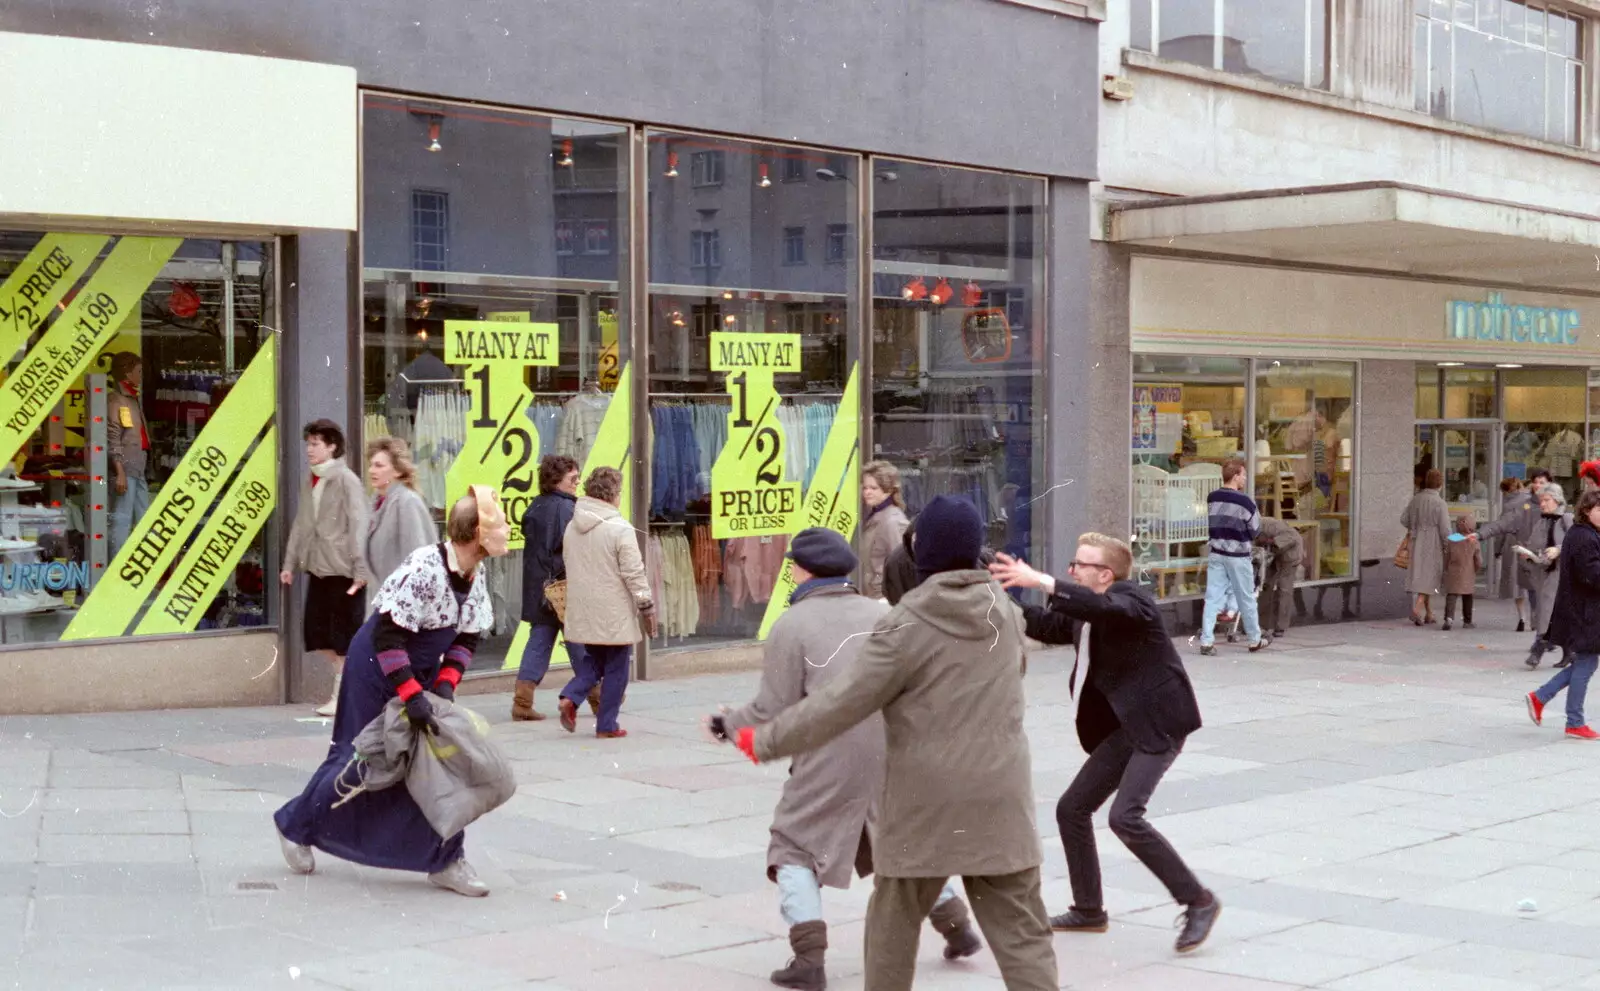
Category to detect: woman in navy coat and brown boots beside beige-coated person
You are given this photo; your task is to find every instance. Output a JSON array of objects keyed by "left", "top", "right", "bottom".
[{"left": 510, "top": 455, "right": 584, "bottom": 722}]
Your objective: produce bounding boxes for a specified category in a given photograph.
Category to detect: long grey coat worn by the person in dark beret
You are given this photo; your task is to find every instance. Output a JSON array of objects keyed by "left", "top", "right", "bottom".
[{"left": 725, "top": 584, "right": 890, "bottom": 889}]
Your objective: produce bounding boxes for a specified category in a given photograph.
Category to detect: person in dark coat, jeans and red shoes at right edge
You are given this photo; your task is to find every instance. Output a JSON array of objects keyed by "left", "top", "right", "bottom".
[{"left": 1528, "top": 491, "right": 1600, "bottom": 740}]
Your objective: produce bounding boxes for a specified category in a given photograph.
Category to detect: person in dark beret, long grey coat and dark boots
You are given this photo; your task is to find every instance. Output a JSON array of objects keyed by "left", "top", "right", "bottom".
[{"left": 707, "top": 527, "right": 982, "bottom": 989}]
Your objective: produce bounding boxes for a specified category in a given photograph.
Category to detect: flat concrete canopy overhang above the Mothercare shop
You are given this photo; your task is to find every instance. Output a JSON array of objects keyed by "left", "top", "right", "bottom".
[{"left": 1109, "top": 183, "right": 1600, "bottom": 293}]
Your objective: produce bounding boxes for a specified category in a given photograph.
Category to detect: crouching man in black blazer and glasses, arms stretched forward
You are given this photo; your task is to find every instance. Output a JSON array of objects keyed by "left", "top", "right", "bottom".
[{"left": 989, "top": 533, "right": 1222, "bottom": 953}]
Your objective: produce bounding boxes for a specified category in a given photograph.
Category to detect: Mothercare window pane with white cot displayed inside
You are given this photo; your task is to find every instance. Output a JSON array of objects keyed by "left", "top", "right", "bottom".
[{"left": 1130, "top": 355, "right": 1250, "bottom": 599}]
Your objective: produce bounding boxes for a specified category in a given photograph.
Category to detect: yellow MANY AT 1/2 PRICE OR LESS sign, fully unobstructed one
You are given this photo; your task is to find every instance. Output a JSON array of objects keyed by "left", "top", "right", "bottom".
[{"left": 710, "top": 333, "right": 800, "bottom": 540}]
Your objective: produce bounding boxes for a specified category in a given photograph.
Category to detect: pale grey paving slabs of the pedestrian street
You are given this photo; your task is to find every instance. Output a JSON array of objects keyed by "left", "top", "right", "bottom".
[{"left": 0, "top": 592, "right": 1600, "bottom": 991}]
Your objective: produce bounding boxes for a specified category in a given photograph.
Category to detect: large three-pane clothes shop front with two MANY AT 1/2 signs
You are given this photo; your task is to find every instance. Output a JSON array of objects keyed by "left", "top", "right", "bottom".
[{"left": 362, "top": 93, "right": 1045, "bottom": 669}]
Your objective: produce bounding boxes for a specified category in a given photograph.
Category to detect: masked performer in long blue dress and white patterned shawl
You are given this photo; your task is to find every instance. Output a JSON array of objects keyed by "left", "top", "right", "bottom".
[{"left": 274, "top": 485, "right": 510, "bottom": 897}]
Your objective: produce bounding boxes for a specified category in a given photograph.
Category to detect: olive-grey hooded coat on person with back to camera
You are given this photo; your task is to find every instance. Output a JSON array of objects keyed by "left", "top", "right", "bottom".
[{"left": 755, "top": 570, "right": 1043, "bottom": 879}]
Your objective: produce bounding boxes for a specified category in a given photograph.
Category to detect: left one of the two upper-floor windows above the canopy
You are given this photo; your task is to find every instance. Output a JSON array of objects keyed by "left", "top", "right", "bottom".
[{"left": 1131, "top": 0, "right": 1330, "bottom": 90}]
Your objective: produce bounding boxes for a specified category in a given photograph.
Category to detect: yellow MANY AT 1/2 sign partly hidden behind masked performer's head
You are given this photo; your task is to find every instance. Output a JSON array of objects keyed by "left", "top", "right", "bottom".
[{"left": 445, "top": 314, "right": 560, "bottom": 551}]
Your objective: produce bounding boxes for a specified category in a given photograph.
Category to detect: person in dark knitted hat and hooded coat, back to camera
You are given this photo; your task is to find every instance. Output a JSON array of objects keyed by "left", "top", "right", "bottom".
[{"left": 736, "top": 496, "right": 1059, "bottom": 991}]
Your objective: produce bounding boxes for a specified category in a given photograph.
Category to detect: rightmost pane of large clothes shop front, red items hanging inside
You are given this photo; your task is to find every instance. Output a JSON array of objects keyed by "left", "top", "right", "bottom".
[{"left": 872, "top": 160, "right": 1049, "bottom": 567}]
